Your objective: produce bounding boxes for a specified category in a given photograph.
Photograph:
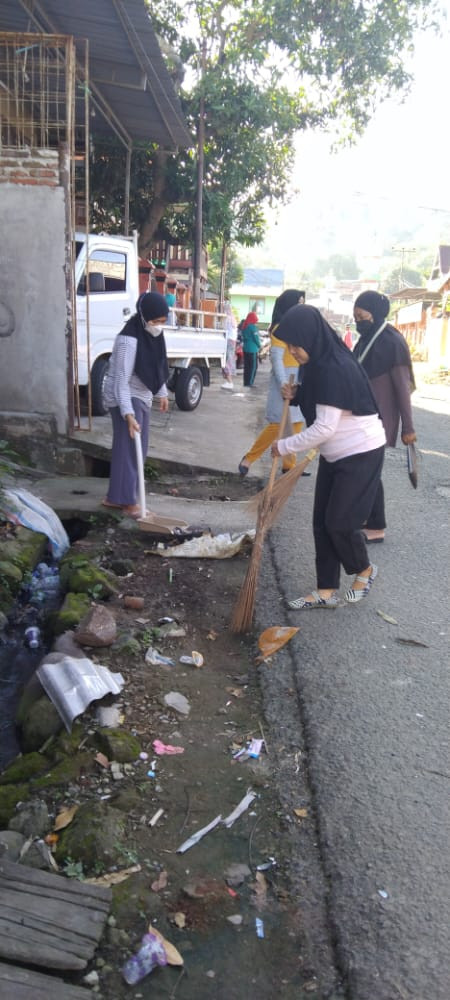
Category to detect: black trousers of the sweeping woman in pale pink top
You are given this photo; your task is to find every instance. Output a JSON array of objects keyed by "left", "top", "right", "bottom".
[{"left": 313, "top": 447, "right": 384, "bottom": 590}]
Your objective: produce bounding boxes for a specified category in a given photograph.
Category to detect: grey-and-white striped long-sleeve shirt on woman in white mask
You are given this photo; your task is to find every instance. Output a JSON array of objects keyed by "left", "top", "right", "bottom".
[{"left": 104, "top": 334, "right": 167, "bottom": 417}]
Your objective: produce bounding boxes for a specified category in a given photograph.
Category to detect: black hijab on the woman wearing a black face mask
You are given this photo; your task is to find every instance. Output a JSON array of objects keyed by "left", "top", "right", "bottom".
[{"left": 353, "top": 290, "right": 415, "bottom": 391}]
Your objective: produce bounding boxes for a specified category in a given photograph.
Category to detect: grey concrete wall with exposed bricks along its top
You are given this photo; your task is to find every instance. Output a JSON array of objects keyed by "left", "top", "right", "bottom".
[{"left": 0, "top": 150, "right": 68, "bottom": 434}]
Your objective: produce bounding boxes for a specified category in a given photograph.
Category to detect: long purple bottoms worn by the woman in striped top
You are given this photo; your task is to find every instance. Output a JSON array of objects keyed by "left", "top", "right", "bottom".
[{"left": 107, "top": 397, "right": 150, "bottom": 507}]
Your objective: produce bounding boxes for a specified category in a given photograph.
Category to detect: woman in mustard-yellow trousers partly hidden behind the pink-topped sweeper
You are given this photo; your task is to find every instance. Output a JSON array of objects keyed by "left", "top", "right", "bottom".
[{"left": 238, "top": 288, "right": 305, "bottom": 476}]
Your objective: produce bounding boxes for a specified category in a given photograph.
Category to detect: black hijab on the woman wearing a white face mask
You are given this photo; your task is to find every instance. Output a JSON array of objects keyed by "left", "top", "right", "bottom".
[{"left": 119, "top": 292, "right": 169, "bottom": 395}]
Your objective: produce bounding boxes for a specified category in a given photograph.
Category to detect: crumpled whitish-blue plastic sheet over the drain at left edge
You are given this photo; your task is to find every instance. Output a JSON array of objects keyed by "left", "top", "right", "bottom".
[{"left": 2, "top": 486, "right": 70, "bottom": 559}]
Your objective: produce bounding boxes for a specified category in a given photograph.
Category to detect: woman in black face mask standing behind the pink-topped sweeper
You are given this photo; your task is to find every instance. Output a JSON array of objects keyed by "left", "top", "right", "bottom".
[{"left": 353, "top": 291, "right": 416, "bottom": 542}]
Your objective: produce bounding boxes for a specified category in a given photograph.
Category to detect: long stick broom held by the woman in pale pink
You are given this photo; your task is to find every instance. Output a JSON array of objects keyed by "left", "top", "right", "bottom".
[{"left": 231, "top": 376, "right": 294, "bottom": 632}]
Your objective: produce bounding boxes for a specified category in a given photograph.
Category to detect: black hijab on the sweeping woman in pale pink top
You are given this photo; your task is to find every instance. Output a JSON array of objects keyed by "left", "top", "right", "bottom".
[{"left": 277, "top": 306, "right": 378, "bottom": 427}]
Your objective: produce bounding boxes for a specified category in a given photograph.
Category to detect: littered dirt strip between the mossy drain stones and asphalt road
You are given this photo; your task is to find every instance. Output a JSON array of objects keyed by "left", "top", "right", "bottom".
[{"left": 48, "top": 476, "right": 330, "bottom": 1000}]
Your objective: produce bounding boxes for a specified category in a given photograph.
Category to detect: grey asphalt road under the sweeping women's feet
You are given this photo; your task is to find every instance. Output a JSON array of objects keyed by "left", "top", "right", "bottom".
[{"left": 257, "top": 388, "right": 450, "bottom": 1000}]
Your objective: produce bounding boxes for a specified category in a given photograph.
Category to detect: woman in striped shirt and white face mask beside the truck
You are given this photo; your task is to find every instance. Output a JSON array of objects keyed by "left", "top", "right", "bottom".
[{"left": 102, "top": 292, "right": 169, "bottom": 517}]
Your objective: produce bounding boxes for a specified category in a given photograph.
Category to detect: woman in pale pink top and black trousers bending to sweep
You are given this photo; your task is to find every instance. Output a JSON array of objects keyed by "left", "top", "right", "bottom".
[{"left": 272, "top": 305, "right": 386, "bottom": 610}]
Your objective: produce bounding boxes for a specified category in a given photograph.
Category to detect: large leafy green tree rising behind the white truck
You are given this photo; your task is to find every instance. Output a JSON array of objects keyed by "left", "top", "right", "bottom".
[{"left": 92, "top": 0, "right": 435, "bottom": 254}]
